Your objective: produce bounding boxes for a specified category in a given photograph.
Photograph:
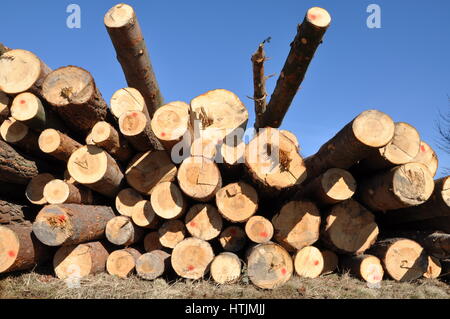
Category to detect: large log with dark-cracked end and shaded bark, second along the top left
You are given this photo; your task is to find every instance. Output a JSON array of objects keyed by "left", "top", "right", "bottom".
[{"left": 42, "top": 66, "right": 108, "bottom": 135}]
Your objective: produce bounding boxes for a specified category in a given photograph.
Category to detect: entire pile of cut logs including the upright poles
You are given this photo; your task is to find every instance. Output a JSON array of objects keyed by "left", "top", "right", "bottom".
[{"left": 0, "top": 4, "right": 450, "bottom": 289}]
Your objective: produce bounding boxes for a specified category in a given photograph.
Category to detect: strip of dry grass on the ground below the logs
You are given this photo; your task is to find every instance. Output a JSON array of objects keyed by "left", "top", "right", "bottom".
[{"left": 0, "top": 272, "right": 450, "bottom": 299}]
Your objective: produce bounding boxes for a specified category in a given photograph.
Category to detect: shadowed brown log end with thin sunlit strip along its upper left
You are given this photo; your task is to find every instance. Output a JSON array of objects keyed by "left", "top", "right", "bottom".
[{"left": 125, "top": 151, "right": 177, "bottom": 195}]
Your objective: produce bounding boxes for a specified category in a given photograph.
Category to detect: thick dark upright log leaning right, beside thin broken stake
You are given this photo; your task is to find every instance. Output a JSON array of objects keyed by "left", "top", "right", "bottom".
[{"left": 257, "top": 7, "right": 331, "bottom": 128}]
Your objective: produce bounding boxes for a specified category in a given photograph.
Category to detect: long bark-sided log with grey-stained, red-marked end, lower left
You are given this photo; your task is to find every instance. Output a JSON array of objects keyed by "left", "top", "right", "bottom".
[{"left": 33, "top": 204, "right": 115, "bottom": 246}]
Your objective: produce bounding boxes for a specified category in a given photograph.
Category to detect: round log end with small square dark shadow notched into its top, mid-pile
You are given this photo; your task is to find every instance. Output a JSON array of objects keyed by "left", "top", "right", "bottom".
[{"left": 216, "top": 182, "right": 258, "bottom": 223}]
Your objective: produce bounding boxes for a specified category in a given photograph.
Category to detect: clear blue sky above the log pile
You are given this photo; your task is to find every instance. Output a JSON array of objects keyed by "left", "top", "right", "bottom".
[{"left": 0, "top": 0, "right": 450, "bottom": 176}]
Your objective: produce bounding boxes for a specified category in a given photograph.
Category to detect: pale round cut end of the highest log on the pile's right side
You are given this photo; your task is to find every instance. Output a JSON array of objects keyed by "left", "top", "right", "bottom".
[{"left": 352, "top": 110, "right": 395, "bottom": 147}]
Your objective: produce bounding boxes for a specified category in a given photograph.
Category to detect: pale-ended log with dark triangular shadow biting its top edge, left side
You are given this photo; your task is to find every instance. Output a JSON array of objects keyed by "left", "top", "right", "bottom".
[{"left": 67, "top": 145, "right": 124, "bottom": 197}]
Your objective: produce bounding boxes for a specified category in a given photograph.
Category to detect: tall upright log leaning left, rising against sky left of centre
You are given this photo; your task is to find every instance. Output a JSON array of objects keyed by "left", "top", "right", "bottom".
[{"left": 104, "top": 3, "right": 163, "bottom": 116}]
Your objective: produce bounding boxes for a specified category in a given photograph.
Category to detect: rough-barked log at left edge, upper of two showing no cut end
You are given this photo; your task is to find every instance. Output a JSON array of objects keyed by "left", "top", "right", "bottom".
[{"left": 0, "top": 140, "right": 39, "bottom": 185}]
